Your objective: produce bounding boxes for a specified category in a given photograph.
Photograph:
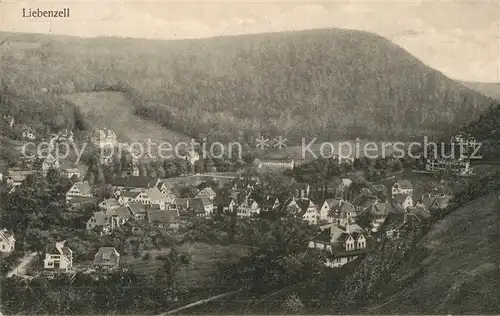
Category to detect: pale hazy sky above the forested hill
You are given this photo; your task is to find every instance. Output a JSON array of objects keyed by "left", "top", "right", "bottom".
[{"left": 0, "top": 0, "right": 500, "bottom": 82}]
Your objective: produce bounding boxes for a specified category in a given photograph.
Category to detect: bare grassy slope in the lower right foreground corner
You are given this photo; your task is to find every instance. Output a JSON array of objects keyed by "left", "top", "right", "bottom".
[{"left": 336, "top": 179, "right": 500, "bottom": 314}]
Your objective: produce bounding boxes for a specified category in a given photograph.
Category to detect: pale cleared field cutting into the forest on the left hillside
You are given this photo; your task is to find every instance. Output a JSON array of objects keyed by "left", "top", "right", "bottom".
[{"left": 63, "top": 91, "right": 190, "bottom": 145}]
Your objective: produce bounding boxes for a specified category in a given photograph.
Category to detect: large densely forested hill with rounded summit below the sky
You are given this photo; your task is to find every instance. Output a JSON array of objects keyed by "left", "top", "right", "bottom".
[{"left": 0, "top": 29, "right": 492, "bottom": 142}]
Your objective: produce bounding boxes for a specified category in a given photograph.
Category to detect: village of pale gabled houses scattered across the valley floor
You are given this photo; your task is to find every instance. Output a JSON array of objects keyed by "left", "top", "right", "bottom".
[{"left": 0, "top": 123, "right": 475, "bottom": 277}]
